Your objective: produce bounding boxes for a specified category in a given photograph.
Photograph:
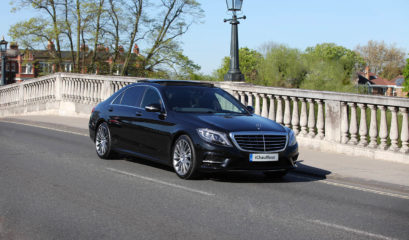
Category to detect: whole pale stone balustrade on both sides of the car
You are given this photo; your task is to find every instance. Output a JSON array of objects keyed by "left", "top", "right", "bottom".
[{"left": 0, "top": 73, "right": 409, "bottom": 163}]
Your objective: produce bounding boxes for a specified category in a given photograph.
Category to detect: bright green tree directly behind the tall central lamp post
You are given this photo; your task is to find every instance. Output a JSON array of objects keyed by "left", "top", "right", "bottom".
[{"left": 215, "top": 47, "right": 263, "bottom": 83}]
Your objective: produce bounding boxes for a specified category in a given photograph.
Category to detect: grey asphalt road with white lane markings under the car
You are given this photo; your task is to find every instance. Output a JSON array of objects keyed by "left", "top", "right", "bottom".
[{"left": 0, "top": 122, "right": 409, "bottom": 240}]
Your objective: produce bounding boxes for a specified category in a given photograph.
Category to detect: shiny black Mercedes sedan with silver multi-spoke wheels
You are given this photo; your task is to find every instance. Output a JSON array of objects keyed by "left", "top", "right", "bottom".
[{"left": 89, "top": 80, "right": 298, "bottom": 179}]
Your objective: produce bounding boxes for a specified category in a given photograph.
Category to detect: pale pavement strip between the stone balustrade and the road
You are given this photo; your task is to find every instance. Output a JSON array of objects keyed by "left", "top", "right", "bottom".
[{"left": 0, "top": 115, "right": 409, "bottom": 193}]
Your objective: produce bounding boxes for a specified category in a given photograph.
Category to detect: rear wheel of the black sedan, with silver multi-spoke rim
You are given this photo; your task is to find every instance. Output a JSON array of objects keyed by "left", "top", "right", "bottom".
[{"left": 95, "top": 122, "right": 114, "bottom": 159}]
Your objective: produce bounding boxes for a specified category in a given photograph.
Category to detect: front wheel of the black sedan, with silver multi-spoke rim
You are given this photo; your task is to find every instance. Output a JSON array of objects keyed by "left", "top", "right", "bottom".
[{"left": 172, "top": 135, "right": 198, "bottom": 179}]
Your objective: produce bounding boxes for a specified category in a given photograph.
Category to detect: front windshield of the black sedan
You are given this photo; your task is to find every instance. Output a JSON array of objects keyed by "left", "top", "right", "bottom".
[{"left": 164, "top": 86, "right": 248, "bottom": 114}]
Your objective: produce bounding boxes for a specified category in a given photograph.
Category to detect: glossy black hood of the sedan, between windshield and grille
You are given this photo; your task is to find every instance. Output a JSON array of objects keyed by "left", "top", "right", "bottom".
[{"left": 177, "top": 114, "right": 286, "bottom": 132}]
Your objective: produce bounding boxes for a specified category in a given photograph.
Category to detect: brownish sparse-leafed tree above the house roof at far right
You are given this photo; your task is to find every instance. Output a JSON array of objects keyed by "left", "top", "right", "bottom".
[{"left": 356, "top": 40, "right": 405, "bottom": 79}]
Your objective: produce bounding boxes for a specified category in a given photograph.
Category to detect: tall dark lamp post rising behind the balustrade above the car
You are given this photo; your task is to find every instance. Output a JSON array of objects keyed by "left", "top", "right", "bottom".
[{"left": 224, "top": 0, "right": 246, "bottom": 82}]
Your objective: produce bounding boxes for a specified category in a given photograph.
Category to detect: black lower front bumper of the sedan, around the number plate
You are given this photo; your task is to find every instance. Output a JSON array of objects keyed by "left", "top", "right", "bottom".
[{"left": 196, "top": 139, "right": 299, "bottom": 172}]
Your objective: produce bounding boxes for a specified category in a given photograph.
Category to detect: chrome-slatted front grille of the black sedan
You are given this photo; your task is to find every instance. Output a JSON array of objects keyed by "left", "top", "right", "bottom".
[{"left": 232, "top": 133, "right": 287, "bottom": 152}]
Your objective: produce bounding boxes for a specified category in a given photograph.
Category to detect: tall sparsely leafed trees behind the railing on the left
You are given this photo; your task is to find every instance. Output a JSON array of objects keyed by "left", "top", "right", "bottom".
[{"left": 10, "top": 0, "right": 203, "bottom": 76}]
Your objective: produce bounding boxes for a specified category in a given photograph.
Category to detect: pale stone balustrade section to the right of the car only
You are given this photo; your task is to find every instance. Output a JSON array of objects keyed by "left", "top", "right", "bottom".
[{"left": 217, "top": 82, "right": 409, "bottom": 162}]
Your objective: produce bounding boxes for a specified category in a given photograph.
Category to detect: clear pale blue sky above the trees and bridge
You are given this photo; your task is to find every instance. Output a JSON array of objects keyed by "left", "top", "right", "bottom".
[{"left": 0, "top": 0, "right": 409, "bottom": 74}]
